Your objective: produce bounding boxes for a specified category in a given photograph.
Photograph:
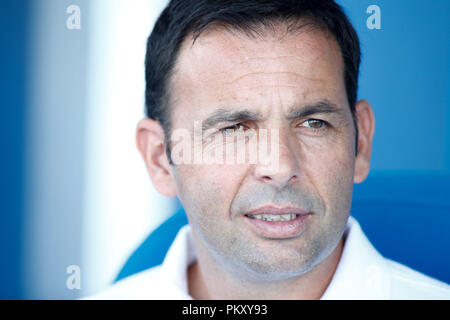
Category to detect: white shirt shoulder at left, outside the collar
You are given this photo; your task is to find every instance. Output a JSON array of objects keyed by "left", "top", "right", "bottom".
[{"left": 83, "top": 266, "right": 180, "bottom": 300}]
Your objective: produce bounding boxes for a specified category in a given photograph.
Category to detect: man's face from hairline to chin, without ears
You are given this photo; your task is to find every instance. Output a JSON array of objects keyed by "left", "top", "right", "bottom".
[{"left": 167, "top": 25, "right": 355, "bottom": 280}]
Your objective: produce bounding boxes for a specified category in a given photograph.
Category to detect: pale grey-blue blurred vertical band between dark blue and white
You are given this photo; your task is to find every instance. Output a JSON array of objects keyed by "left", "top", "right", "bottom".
[{"left": 22, "top": 0, "right": 89, "bottom": 299}]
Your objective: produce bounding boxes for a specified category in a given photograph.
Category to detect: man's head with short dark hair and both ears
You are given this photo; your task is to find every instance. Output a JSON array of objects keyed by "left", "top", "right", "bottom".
[{"left": 138, "top": 0, "right": 374, "bottom": 280}]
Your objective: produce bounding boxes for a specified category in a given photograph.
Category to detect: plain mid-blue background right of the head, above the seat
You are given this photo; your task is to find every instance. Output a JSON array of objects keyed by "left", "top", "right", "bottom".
[{"left": 339, "top": 0, "right": 450, "bottom": 173}]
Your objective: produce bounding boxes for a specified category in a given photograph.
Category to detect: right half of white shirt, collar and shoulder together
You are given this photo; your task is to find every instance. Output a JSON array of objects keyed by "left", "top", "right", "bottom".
[{"left": 337, "top": 218, "right": 450, "bottom": 300}]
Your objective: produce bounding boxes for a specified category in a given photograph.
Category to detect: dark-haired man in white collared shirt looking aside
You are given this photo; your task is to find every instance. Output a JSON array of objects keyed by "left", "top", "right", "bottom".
[{"left": 89, "top": 0, "right": 450, "bottom": 299}]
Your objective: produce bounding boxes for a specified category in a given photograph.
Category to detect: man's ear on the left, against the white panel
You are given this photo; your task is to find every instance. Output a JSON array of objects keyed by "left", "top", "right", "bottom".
[{"left": 136, "top": 118, "right": 177, "bottom": 197}]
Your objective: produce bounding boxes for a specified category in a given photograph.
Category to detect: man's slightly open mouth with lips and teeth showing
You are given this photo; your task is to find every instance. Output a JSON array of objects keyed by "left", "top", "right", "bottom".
[{"left": 243, "top": 206, "right": 311, "bottom": 239}]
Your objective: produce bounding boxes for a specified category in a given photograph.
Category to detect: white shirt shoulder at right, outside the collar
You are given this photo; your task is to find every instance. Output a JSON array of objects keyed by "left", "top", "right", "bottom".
[{"left": 386, "top": 259, "right": 450, "bottom": 300}]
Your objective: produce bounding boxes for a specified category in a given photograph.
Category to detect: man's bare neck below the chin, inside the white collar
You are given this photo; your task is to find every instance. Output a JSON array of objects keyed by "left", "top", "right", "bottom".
[{"left": 188, "top": 237, "right": 344, "bottom": 300}]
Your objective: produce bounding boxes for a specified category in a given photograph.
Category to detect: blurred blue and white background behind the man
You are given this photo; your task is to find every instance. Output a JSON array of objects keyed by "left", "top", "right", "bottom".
[{"left": 0, "top": 0, "right": 450, "bottom": 299}]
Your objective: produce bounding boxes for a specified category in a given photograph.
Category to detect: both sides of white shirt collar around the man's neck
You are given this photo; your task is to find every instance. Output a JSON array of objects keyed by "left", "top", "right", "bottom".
[{"left": 163, "top": 217, "right": 390, "bottom": 300}]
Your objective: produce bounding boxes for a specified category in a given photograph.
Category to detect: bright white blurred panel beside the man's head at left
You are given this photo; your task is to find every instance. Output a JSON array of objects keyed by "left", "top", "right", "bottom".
[{"left": 82, "top": 0, "right": 174, "bottom": 294}]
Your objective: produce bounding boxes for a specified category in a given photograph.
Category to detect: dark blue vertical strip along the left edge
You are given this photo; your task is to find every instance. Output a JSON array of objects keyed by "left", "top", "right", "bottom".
[{"left": 0, "top": 0, "right": 28, "bottom": 299}]
